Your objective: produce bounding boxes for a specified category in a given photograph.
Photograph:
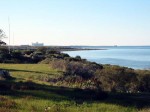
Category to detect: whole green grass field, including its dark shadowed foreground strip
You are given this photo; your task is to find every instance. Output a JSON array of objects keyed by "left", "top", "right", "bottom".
[{"left": 0, "top": 64, "right": 150, "bottom": 112}]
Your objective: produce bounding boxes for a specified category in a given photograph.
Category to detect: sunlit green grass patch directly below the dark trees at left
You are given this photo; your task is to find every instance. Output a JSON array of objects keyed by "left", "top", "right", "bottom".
[{"left": 0, "top": 64, "right": 60, "bottom": 80}]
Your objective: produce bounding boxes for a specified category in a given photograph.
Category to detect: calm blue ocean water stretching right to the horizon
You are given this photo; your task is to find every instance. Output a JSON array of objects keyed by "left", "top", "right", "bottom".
[{"left": 64, "top": 46, "right": 150, "bottom": 69}]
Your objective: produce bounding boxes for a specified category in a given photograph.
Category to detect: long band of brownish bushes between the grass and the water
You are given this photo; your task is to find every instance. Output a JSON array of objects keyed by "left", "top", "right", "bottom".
[{"left": 49, "top": 59, "right": 150, "bottom": 93}]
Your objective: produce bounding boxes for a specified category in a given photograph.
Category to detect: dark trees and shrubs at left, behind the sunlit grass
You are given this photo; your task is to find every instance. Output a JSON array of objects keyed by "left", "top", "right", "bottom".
[{"left": 0, "top": 46, "right": 45, "bottom": 63}]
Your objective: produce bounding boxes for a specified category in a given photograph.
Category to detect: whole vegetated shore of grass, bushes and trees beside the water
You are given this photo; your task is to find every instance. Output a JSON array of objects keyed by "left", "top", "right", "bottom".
[{"left": 0, "top": 46, "right": 150, "bottom": 112}]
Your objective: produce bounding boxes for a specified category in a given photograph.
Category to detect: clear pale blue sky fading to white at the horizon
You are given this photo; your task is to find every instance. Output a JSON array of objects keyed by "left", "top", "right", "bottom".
[{"left": 0, "top": 0, "right": 150, "bottom": 46}]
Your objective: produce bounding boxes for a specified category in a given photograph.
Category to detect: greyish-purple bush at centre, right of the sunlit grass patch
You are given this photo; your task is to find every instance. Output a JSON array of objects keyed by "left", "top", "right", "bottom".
[{"left": 50, "top": 60, "right": 103, "bottom": 79}]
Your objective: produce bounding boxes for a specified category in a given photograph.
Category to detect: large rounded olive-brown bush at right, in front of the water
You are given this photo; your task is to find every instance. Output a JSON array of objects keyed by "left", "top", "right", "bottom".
[{"left": 96, "top": 65, "right": 138, "bottom": 92}]
